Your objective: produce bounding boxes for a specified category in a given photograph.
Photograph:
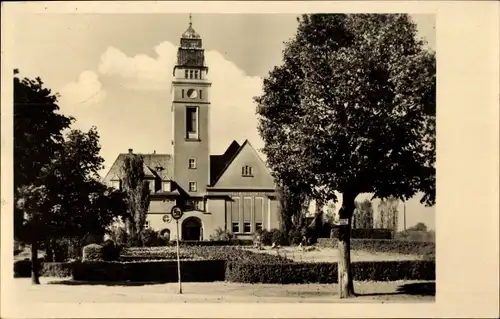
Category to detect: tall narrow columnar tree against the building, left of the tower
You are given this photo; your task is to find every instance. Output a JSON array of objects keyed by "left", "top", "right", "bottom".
[{"left": 121, "top": 154, "right": 151, "bottom": 236}]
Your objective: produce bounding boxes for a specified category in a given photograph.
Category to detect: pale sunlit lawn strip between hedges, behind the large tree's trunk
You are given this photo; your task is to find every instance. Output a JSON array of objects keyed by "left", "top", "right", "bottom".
[{"left": 244, "top": 247, "right": 422, "bottom": 262}]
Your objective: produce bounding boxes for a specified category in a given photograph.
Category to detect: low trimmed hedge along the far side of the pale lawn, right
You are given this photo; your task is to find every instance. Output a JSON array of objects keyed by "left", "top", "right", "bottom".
[{"left": 318, "top": 238, "right": 436, "bottom": 255}]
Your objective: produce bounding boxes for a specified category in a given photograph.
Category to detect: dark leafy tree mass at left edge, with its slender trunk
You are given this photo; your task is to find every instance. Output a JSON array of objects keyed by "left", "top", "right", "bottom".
[{"left": 14, "top": 72, "right": 125, "bottom": 284}]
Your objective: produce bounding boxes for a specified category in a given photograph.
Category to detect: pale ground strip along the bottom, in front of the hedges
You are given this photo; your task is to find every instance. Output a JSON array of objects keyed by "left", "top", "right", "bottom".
[{"left": 12, "top": 277, "right": 435, "bottom": 307}]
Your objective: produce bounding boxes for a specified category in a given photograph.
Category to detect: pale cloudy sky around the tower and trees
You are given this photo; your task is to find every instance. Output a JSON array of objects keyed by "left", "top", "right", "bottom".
[{"left": 12, "top": 13, "right": 436, "bottom": 228}]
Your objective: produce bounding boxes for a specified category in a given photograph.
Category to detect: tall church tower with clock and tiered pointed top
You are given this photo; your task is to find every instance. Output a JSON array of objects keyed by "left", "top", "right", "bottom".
[{"left": 172, "top": 15, "right": 211, "bottom": 199}]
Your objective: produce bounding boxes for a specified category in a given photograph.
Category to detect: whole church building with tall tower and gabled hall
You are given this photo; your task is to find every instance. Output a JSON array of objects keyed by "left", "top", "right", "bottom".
[{"left": 104, "top": 21, "right": 279, "bottom": 240}]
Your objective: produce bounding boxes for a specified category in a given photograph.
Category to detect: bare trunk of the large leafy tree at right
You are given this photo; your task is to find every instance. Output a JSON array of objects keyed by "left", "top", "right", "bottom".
[{"left": 338, "top": 192, "right": 357, "bottom": 299}]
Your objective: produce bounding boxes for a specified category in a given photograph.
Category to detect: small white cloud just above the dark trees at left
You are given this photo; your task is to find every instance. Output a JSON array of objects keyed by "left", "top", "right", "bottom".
[{"left": 60, "top": 71, "right": 106, "bottom": 108}]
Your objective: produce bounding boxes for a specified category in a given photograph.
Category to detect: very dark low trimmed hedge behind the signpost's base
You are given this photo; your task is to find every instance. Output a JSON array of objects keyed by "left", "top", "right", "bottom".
[{"left": 73, "top": 260, "right": 225, "bottom": 282}]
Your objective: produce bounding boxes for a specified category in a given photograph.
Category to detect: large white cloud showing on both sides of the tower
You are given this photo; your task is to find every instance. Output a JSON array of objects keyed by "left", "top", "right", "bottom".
[{"left": 98, "top": 42, "right": 262, "bottom": 153}]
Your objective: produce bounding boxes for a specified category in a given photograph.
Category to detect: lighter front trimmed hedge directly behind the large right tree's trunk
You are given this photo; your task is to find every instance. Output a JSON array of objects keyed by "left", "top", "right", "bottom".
[{"left": 226, "top": 261, "right": 436, "bottom": 284}]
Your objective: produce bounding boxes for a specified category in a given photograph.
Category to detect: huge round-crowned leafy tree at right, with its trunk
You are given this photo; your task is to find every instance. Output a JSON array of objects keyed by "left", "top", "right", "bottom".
[{"left": 256, "top": 14, "right": 436, "bottom": 298}]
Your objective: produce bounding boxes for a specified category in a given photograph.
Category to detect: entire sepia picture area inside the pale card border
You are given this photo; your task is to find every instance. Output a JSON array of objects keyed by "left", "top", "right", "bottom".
[{"left": 2, "top": 1, "right": 498, "bottom": 318}]
